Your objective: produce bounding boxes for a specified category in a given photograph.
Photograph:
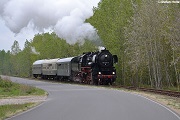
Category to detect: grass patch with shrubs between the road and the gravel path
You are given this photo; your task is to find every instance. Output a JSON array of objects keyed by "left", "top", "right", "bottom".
[{"left": 0, "top": 78, "right": 46, "bottom": 98}]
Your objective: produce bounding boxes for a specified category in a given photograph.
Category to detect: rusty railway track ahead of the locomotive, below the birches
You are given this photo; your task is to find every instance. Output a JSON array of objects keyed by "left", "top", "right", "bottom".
[{"left": 116, "top": 86, "right": 180, "bottom": 98}]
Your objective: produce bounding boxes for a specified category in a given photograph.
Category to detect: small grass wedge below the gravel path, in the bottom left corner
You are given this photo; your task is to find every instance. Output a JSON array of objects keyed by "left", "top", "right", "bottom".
[{"left": 0, "top": 103, "right": 36, "bottom": 120}]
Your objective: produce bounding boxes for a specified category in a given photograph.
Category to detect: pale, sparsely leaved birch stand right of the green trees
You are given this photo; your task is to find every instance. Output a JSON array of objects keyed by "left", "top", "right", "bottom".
[{"left": 125, "top": 0, "right": 180, "bottom": 89}]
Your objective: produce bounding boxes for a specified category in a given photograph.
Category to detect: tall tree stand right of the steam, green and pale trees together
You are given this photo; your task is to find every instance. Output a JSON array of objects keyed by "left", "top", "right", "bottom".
[{"left": 87, "top": 0, "right": 180, "bottom": 89}]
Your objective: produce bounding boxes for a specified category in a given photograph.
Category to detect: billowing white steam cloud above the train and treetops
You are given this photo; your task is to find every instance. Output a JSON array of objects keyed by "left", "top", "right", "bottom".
[{"left": 0, "top": 0, "right": 100, "bottom": 44}]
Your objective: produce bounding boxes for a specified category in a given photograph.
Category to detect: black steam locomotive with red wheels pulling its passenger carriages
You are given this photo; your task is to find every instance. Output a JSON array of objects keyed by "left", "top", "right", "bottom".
[{"left": 32, "top": 48, "right": 118, "bottom": 85}]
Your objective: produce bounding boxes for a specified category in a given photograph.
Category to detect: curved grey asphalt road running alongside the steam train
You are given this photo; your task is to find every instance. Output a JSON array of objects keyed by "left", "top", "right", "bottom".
[{"left": 3, "top": 77, "right": 180, "bottom": 120}]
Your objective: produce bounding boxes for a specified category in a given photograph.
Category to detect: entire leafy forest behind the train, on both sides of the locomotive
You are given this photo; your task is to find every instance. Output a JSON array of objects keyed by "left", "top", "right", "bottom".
[{"left": 0, "top": 0, "right": 180, "bottom": 91}]
